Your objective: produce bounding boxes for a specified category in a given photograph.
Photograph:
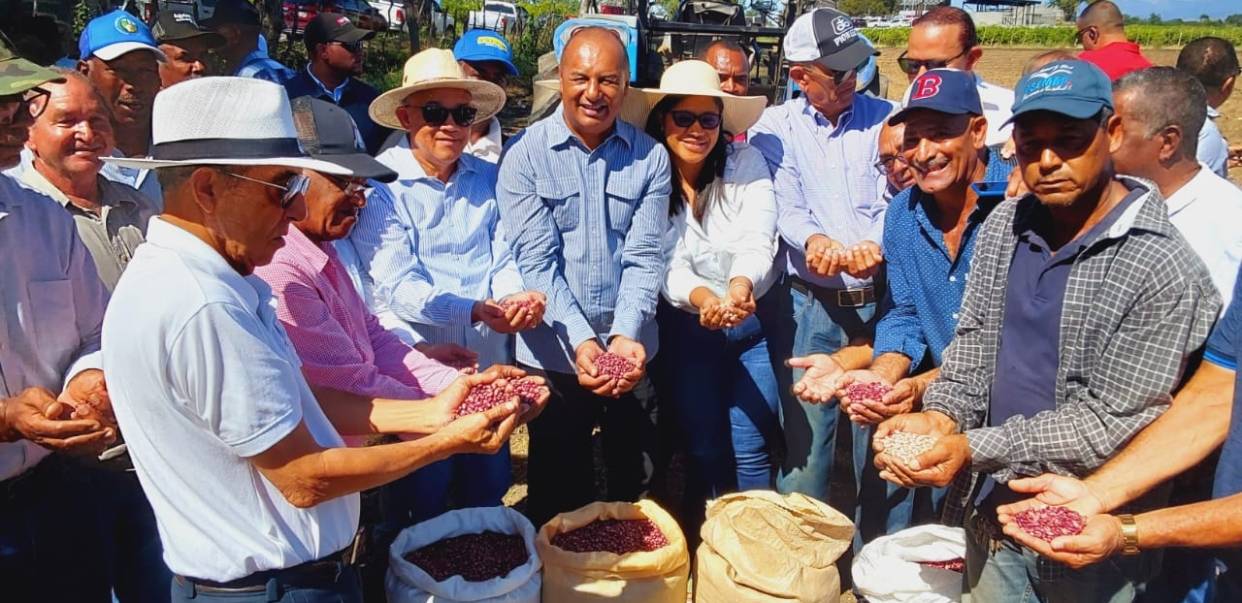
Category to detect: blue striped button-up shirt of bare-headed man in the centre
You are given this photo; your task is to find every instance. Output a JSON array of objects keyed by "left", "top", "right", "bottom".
[{"left": 497, "top": 109, "right": 671, "bottom": 373}]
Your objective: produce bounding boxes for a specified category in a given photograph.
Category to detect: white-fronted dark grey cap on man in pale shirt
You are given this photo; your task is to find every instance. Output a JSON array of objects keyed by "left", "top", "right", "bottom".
[{"left": 784, "top": 9, "right": 878, "bottom": 71}]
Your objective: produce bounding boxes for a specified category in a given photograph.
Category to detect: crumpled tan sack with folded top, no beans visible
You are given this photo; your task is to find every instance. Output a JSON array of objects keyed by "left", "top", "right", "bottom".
[{"left": 694, "top": 490, "right": 854, "bottom": 603}]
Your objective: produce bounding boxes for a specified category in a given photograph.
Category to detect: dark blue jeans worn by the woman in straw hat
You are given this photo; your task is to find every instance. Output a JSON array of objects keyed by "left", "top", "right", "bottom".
[{"left": 656, "top": 295, "right": 784, "bottom": 534}]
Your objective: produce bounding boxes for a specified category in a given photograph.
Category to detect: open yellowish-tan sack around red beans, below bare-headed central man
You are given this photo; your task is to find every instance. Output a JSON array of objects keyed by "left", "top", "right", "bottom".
[{"left": 535, "top": 500, "right": 689, "bottom": 603}]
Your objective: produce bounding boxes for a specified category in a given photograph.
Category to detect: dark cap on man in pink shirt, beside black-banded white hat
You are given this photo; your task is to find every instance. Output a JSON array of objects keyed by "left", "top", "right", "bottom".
[{"left": 291, "top": 97, "right": 396, "bottom": 182}]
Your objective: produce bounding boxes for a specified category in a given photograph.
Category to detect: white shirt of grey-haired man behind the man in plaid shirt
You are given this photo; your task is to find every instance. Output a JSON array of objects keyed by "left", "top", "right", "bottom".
[{"left": 1165, "top": 164, "right": 1242, "bottom": 308}]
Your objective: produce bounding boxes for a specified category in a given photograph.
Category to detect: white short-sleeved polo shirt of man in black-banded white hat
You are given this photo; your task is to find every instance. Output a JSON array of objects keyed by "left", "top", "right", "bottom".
[{"left": 103, "top": 217, "right": 359, "bottom": 582}]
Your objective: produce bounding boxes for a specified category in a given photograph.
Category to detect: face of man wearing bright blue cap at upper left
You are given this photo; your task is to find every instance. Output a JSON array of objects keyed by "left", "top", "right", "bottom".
[{"left": 81, "top": 50, "right": 160, "bottom": 128}]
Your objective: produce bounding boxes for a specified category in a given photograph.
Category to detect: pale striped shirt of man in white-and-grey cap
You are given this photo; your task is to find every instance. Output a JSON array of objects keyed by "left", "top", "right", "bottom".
[{"left": 750, "top": 94, "right": 893, "bottom": 289}]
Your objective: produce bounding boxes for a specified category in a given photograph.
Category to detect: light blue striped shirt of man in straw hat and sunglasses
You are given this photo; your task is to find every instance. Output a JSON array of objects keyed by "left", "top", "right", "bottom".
[{"left": 350, "top": 136, "right": 523, "bottom": 366}]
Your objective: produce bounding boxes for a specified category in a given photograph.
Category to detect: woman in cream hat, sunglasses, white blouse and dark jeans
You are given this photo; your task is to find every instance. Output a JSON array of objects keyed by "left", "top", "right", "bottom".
[{"left": 641, "top": 61, "right": 780, "bottom": 536}]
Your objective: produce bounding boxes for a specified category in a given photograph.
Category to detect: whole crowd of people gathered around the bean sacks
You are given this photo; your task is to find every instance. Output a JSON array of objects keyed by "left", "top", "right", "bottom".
[{"left": 0, "top": 0, "right": 1242, "bottom": 603}]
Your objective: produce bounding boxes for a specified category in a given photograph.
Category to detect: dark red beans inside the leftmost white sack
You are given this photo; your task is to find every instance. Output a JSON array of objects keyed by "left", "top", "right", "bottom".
[{"left": 405, "top": 531, "right": 530, "bottom": 582}]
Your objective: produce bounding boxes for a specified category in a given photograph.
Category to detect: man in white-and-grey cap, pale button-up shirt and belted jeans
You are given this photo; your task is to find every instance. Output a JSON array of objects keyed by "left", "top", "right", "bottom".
[{"left": 750, "top": 9, "right": 893, "bottom": 512}]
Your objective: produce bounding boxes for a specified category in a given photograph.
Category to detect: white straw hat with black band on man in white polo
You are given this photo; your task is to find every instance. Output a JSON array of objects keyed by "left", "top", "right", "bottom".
[{"left": 101, "top": 77, "right": 353, "bottom": 176}]
